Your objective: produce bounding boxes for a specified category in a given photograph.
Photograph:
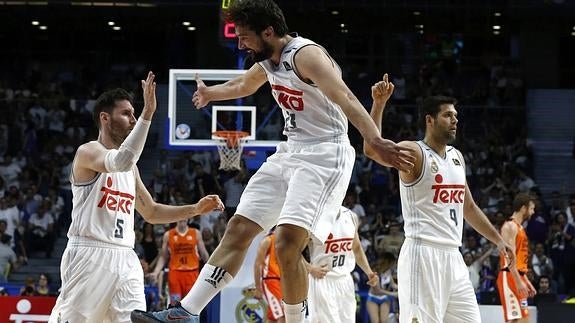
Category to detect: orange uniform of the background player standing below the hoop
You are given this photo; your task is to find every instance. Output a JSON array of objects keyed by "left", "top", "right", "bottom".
[{"left": 168, "top": 228, "right": 200, "bottom": 300}]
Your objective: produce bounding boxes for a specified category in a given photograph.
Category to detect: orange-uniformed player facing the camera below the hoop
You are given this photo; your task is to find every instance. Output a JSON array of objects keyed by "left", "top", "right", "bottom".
[{"left": 152, "top": 220, "right": 210, "bottom": 304}]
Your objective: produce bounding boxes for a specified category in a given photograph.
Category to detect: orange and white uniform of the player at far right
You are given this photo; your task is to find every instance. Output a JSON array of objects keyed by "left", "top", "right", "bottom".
[{"left": 497, "top": 221, "right": 529, "bottom": 322}]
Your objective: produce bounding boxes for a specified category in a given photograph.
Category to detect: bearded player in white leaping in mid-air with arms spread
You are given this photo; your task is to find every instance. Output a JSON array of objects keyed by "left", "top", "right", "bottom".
[{"left": 132, "top": 0, "right": 413, "bottom": 323}]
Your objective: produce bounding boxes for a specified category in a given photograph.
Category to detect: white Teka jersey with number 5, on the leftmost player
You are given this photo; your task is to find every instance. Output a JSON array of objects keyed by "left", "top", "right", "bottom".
[{"left": 68, "top": 166, "right": 136, "bottom": 248}]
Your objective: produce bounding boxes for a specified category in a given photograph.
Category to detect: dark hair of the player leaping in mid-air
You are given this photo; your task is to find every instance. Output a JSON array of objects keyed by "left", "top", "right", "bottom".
[{"left": 224, "top": 0, "right": 288, "bottom": 37}]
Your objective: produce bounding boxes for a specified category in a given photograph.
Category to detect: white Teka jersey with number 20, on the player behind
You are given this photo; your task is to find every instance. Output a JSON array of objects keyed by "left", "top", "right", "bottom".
[{"left": 308, "top": 206, "right": 358, "bottom": 277}]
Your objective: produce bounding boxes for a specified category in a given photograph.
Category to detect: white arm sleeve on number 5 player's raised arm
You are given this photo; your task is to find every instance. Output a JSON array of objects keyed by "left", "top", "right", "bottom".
[{"left": 104, "top": 118, "right": 151, "bottom": 173}]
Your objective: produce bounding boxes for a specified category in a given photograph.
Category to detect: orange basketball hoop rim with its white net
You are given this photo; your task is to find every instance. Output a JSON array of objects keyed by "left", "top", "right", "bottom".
[{"left": 213, "top": 130, "right": 250, "bottom": 170}]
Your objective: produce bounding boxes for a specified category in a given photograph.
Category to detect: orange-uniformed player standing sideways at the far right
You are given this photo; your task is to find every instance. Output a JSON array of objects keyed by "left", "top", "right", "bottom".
[{"left": 497, "top": 193, "right": 537, "bottom": 322}]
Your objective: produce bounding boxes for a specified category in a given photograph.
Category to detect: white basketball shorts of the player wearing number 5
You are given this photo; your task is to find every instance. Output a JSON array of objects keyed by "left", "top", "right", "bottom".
[{"left": 49, "top": 237, "right": 146, "bottom": 323}]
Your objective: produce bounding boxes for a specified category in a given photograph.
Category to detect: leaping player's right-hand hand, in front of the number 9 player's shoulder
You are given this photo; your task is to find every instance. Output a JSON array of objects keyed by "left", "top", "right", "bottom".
[{"left": 370, "top": 137, "right": 415, "bottom": 173}]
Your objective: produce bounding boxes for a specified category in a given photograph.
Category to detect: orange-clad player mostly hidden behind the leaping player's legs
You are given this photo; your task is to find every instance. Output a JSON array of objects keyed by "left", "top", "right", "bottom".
[{"left": 254, "top": 227, "right": 285, "bottom": 323}]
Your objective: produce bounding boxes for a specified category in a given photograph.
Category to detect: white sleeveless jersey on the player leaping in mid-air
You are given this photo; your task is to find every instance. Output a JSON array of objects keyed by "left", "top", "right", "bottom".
[{"left": 259, "top": 36, "right": 347, "bottom": 141}]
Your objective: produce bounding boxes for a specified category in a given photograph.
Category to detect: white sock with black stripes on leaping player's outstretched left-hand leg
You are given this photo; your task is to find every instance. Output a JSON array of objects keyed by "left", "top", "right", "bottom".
[{"left": 180, "top": 264, "right": 234, "bottom": 315}]
